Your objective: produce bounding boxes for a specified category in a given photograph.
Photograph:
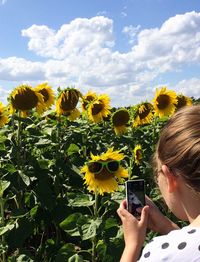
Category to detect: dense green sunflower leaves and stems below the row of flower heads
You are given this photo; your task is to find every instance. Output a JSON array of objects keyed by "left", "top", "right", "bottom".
[{"left": 0, "top": 109, "right": 191, "bottom": 262}]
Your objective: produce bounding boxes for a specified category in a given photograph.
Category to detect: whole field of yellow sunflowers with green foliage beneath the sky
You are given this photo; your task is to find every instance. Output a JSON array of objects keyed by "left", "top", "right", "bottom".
[{"left": 0, "top": 83, "right": 198, "bottom": 262}]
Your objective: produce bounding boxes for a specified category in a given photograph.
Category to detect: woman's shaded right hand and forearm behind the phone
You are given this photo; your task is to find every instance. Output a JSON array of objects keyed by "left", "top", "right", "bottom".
[{"left": 141, "top": 196, "right": 179, "bottom": 235}]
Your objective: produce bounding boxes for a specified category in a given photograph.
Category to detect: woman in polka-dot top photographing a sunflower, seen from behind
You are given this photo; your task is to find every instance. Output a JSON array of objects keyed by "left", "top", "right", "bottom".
[{"left": 117, "top": 105, "right": 200, "bottom": 262}]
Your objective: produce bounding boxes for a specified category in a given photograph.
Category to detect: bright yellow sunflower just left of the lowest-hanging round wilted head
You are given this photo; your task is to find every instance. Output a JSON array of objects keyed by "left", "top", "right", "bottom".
[{"left": 88, "top": 95, "right": 111, "bottom": 123}]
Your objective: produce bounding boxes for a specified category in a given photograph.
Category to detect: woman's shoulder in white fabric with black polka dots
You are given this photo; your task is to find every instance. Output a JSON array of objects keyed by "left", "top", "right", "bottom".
[{"left": 139, "top": 226, "right": 200, "bottom": 262}]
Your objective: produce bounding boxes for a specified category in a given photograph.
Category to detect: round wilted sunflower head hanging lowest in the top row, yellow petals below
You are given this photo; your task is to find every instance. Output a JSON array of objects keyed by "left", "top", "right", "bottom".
[{"left": 111, "top": 108, "right": 130, "bottom": 135}]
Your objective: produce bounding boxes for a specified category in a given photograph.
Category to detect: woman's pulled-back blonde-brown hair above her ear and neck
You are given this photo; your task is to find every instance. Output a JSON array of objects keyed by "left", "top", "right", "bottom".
[{"left": 154, "top": 105, "right": 200, "bottom": 192}]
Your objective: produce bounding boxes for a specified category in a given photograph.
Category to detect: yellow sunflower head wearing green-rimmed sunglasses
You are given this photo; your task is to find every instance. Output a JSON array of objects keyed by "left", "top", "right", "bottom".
[{"left": 81, "top": 148, "right": 128, "bottom": 195}]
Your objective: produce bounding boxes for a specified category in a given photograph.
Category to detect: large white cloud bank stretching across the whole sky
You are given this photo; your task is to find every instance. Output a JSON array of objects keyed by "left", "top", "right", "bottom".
[{"left": 0, "top": 12, "right": 200, "bottom": 106}]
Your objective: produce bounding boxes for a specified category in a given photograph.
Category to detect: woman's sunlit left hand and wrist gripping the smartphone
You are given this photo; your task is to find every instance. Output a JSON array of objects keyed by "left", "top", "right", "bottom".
[{"left": 117, "top": 200, "right": 149, "bottom": 262}]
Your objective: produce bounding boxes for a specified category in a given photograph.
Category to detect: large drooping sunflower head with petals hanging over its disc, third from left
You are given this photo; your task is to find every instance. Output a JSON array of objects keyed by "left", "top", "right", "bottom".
[{"left": 56, "top": 87, "right": 81, "bottom": 115}]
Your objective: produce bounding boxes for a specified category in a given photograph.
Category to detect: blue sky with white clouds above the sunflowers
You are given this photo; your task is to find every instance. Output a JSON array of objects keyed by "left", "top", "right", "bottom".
[{"left": 0, "top": 0, "right": 200, "bottom": 107}]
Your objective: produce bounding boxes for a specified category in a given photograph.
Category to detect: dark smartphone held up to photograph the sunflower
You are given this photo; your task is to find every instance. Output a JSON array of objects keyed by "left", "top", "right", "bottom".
[{"left": 125, "top": 179, "right": 145, "bottom": 218}]
